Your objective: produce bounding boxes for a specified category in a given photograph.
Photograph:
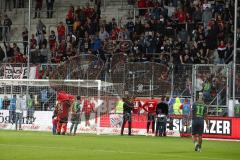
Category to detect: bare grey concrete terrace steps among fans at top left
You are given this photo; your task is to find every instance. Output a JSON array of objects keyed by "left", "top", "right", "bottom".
[{"left": 0, "top": 0, "right": 133, "bottom": 50}]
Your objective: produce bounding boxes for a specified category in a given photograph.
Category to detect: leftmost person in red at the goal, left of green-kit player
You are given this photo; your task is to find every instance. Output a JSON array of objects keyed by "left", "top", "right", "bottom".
[{"left": 57, "top": 100, "right": 72, "bottom": 135}]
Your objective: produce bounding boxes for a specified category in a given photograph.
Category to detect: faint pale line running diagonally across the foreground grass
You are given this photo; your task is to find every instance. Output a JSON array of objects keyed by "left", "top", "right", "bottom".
[{"left": 0, "top": 143, "right": 234, "bottom": 160}]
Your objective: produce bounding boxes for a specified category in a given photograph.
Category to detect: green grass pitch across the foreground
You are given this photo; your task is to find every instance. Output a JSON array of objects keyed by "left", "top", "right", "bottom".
[{"left": 0, "top": 130, "right": 240, "bottom": 160}]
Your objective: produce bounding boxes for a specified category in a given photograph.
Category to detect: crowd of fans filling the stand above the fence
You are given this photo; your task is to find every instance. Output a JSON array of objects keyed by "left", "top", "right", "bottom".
[{"left": 1, "top": 0, "right": 240, "bottom": 64}]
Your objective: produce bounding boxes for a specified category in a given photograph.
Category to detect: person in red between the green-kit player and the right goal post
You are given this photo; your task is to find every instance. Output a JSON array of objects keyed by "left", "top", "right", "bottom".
[{"left": 82, "top": 98, "right": 95, "bottom": 127}]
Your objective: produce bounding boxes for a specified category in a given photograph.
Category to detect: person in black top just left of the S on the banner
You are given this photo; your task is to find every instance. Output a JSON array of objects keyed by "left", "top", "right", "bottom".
[{"left": 155, "top": 97, "right": 168, "bottom": 136}]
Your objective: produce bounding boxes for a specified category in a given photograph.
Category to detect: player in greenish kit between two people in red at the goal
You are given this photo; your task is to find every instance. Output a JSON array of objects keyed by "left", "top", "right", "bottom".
[{"left": 70, "top": 96, "right": 81, "bottom": 135}]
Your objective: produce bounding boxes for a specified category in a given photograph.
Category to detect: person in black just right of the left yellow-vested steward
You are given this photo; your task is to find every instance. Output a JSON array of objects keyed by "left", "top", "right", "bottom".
[{"left": 121, "top": 97, "right": 134, "bottom": 136}]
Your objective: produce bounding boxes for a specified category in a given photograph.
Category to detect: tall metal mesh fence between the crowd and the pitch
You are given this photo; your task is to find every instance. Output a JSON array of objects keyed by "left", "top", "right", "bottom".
[{"left": 0, "top": 59, "right": 240, "bottom": 116}]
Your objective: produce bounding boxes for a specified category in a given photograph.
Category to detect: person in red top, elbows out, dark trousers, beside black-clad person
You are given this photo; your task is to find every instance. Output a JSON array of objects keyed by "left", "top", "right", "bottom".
[{"left": 143, "top": 97, "right": 158, "bottom": 135}]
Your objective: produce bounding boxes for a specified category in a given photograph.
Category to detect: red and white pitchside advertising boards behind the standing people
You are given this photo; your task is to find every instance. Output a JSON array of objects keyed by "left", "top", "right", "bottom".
[{"left": 0, "top": 110, "right": 240, "bottom": 139}]
